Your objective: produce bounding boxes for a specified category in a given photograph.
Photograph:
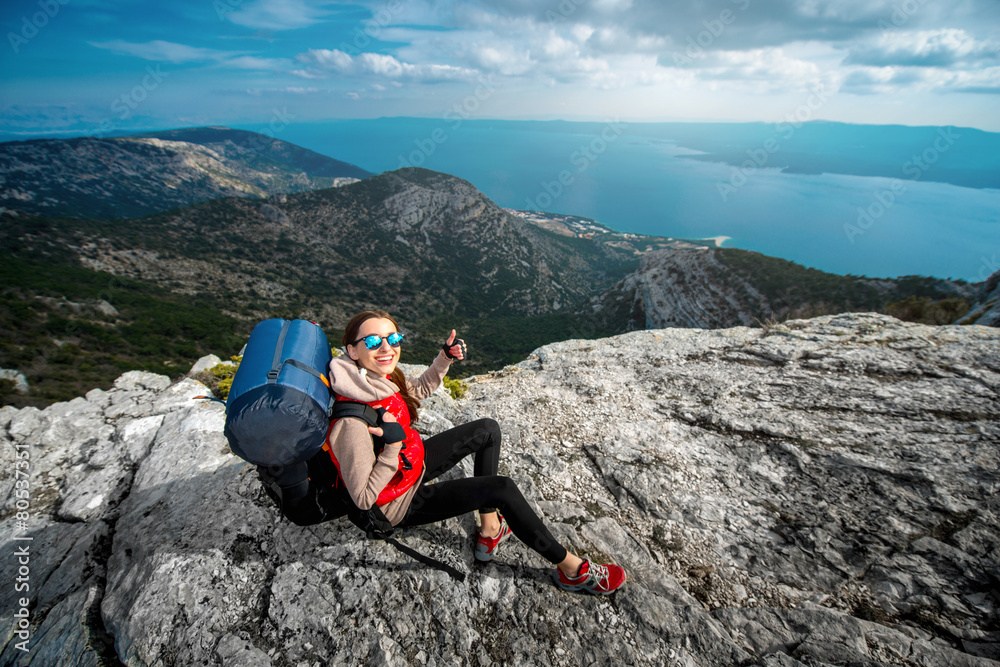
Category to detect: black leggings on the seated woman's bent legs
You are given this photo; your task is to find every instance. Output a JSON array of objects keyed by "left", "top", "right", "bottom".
[{"left": 399, "top": 419, "right": 567, "bottom": 563}]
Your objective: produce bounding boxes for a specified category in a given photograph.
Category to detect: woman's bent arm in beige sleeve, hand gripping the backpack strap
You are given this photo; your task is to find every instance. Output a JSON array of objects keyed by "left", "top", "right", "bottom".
[{"left": 330, "top": 417, "right": 402, "bottom": 510}]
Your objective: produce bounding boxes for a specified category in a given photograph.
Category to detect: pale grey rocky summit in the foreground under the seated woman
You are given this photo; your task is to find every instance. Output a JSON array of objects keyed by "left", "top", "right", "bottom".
[{"left": 0, "top": 314, "right": 1000, "bottom": 667}]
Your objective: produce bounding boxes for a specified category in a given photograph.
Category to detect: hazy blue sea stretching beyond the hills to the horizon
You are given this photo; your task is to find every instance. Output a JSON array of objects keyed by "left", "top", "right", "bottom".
[{"left": 274, "top": 118, "right": 1000, "bottom": 282}]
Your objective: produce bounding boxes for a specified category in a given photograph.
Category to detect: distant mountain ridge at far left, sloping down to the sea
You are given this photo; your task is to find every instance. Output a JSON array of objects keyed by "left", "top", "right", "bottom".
[{"left": 0, "top": 128, "right": 371, "bottom": 218}]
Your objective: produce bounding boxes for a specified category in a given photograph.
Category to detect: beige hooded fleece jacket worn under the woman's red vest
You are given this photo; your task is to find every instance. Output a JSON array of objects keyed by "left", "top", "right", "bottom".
[{"left": 329, "top": 352, "right": 451, "bottom": 526}]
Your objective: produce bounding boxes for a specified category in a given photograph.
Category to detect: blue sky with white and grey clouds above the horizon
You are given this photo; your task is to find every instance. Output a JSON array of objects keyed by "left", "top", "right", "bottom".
[{"left": 0, "top": 0, "right": 1000, "bottom": 136}]
